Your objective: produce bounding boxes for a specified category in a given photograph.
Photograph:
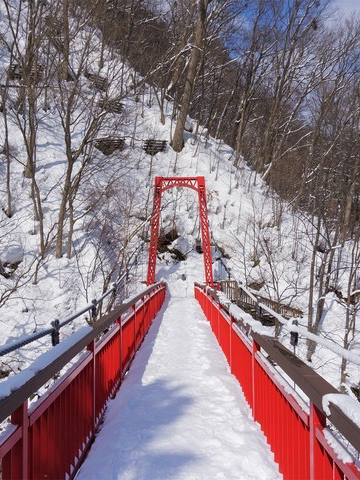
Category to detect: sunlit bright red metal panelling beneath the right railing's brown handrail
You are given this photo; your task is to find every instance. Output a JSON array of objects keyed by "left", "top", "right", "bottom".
[{"left": 195, "top": 286, "right": 360, "bottom": 480}]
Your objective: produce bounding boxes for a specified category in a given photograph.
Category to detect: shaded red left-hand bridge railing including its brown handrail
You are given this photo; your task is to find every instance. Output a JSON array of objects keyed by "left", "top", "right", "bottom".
[{"left": 0, "top": 283, "right": 166, "bottom": 480}]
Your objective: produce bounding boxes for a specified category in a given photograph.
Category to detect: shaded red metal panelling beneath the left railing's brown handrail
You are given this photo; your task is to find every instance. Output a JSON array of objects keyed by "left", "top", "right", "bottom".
[{"left": 0, "top": 286, "right": 165, "bottom": 480}]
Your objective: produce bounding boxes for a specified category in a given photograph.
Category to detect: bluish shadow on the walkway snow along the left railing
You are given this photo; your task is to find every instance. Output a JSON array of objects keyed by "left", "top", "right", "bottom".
[{"left": 77, "top": 292, "right": 197, "bottom": 480}]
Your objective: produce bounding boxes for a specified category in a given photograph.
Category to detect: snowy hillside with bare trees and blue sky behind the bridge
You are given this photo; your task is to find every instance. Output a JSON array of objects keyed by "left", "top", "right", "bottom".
[{"left": 0, "top": 0, "right": 360, "bottom": 393}]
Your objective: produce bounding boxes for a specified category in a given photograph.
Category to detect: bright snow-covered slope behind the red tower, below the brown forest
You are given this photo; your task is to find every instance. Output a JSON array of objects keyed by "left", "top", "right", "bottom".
[{"left": 0, "top": 2, "right": 360, "bottom": 406}]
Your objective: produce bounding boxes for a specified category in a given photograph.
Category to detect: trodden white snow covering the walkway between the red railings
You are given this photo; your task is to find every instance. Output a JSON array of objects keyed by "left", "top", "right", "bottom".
[{"left": 76, "top": 256, "right": 281, "bottom": 480}]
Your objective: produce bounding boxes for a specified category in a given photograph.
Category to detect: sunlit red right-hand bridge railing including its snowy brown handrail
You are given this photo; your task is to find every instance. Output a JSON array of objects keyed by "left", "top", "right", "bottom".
[{"left": 195, "top": 285, "right": 360, "bottom": 480}]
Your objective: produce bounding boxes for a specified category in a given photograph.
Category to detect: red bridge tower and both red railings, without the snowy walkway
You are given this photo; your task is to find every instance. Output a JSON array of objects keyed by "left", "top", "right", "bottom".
[{"left": 0, "top": 177, "right": 360, "bottom": 480}]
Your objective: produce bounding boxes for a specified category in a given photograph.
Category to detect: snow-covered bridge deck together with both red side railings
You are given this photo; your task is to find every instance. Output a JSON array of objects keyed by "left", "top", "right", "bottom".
[{"left": 0, "top": 253, "right": 360, "bottom": 480}]
